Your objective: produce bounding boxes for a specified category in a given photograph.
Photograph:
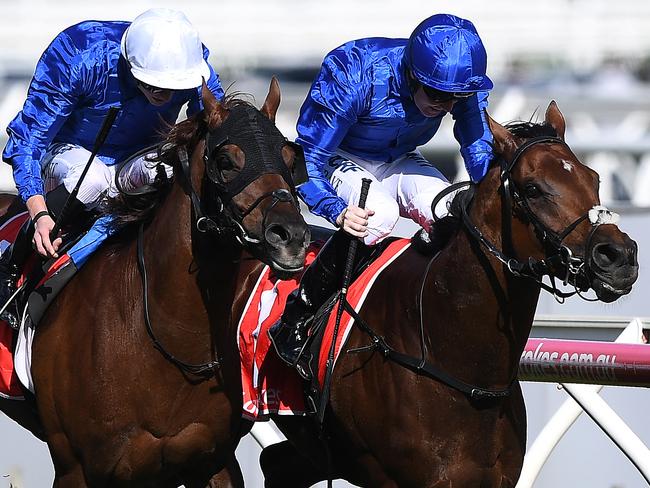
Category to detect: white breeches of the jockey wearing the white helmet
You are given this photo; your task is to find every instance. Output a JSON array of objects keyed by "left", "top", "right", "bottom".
[{"left": 41, "top": 143, "right": 172, "bottom": 207}]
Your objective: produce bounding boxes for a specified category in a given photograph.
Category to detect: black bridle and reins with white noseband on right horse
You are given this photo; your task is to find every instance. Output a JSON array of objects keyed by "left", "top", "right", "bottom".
[{"left": 460, "top": 136, "right": 619, "bottom": 303}]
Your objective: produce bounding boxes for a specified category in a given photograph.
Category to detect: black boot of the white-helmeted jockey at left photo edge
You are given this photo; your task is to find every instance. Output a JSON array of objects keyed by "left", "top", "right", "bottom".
[{"left": 0, "top": 220, "right": 34, "bottom": 329}]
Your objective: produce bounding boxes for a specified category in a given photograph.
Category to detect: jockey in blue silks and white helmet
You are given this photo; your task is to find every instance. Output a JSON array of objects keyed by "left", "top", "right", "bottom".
[{"left": 0, "top": 8, "right": 223, "bottom": 325}]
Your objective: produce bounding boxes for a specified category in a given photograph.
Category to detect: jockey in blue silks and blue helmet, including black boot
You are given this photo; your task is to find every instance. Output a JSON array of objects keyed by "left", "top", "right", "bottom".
[{"left": 269, "top": 14, "right": 493, "bottom": 376}]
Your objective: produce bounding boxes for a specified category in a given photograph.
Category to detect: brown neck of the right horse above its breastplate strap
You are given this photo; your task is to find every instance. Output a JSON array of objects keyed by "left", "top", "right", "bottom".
[{"left": 426, "top": 171, "right": 540, "bottom": 387}]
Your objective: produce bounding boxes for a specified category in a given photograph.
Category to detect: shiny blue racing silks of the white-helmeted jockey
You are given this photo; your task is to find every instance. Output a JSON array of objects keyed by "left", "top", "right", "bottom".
[{"left": 2, "top": 21, "right": 223, "bottom": 201}]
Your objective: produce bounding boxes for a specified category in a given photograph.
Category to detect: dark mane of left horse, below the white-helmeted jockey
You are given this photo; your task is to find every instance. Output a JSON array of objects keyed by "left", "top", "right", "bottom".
[{"left": 100, "top": 92, "right": 253, "bottom": 237}]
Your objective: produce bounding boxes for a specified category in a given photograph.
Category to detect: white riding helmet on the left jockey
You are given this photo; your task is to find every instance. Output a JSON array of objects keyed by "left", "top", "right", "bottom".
[{"left": 122, "top": 8, "right": 210, "bottom": 90}]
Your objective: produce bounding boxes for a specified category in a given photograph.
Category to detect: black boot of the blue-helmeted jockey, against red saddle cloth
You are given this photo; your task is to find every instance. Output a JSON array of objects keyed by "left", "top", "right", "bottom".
[{"left": 269, "top": 230, "right": 370, "bottom": 380}]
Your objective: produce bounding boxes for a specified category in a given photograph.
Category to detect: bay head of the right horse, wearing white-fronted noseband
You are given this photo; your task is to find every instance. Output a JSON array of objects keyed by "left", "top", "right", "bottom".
[{"left": 489, "top": 101, "right": 638, "bottom": 302}]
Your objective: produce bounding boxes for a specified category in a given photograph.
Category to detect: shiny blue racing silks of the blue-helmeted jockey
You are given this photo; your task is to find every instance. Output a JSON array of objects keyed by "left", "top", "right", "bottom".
[{"left": 297, "top": 37, "right": 492, "bottom": 223}]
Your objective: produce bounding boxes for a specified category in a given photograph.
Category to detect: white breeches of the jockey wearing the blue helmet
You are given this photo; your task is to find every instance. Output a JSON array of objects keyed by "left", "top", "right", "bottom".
[{"left": 324, "top": 151, "right": 454, "bottom": 245}]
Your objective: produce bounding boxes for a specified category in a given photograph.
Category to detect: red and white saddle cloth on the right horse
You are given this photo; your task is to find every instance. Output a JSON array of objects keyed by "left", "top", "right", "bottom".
[{"left": 237, "top": 239, "right": 411, "bottom": 421}]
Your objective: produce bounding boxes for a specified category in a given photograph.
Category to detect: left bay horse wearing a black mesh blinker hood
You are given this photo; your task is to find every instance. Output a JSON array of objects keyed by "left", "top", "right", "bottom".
[{"left": 0, "top": 78, "right": 310, "bottom": 488}]
